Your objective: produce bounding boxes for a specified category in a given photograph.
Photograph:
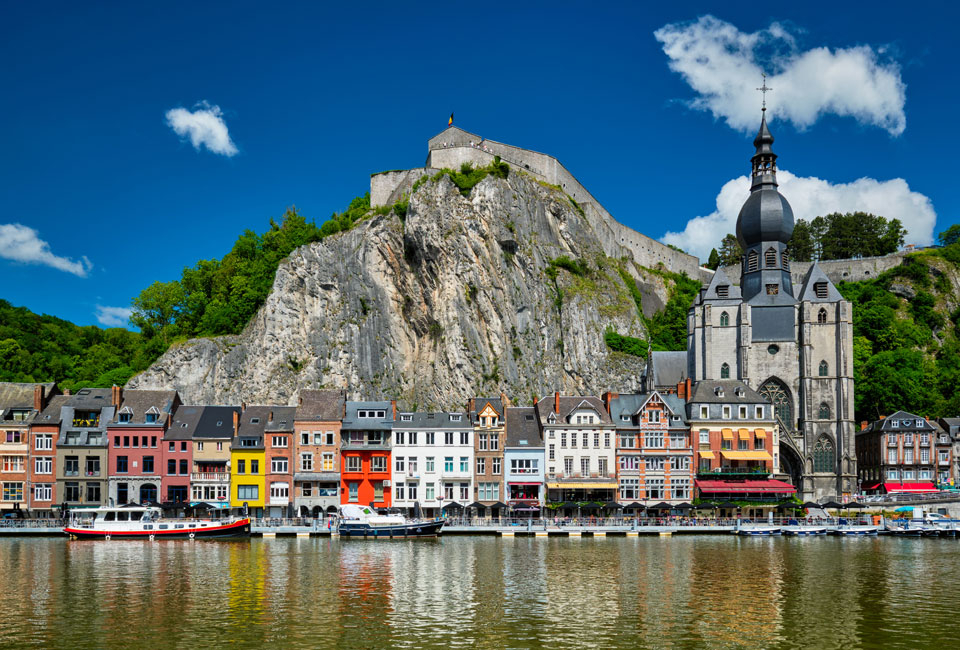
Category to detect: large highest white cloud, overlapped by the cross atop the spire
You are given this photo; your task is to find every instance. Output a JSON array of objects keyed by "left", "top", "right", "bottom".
[{"left": 654, "top": 16, "right": 907, "bottom": 135}]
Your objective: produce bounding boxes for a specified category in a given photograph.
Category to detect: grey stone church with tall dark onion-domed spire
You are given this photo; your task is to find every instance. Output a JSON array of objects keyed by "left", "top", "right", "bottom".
[{"left": 687, "top": 107, "right": 857, "bottom": 500}]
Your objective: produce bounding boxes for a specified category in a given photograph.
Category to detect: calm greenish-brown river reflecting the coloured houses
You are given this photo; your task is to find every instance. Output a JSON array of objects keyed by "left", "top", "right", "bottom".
[{"left": 0, "top": 535, "right": 960, "bottom": 648}]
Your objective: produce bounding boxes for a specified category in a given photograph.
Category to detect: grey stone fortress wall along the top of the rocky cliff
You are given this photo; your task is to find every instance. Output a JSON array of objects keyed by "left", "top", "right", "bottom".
[{"left": 370, "top": 127, "right": 702, "bottom": 278}]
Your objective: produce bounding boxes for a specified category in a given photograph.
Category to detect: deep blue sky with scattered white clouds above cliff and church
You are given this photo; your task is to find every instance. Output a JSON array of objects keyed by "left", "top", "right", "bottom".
[{"left": 0, "top": 2, "right": 960, "bottom": 324}]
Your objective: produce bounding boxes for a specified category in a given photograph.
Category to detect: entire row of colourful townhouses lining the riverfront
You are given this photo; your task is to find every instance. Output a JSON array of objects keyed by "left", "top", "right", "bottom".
[{"left": 0, "top": 380, "right": 960, "bottom": 517}]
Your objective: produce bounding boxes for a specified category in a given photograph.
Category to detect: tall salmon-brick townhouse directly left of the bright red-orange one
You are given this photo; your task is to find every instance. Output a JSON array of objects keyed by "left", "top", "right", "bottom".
[{"left": 293, "top": 390, "right": 346, "bottom": 517}]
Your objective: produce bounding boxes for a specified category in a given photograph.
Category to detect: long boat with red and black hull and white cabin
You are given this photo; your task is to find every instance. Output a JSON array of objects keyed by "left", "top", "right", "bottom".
[{"left": 63, "top": 506, "right": 250, "bottom": 540}]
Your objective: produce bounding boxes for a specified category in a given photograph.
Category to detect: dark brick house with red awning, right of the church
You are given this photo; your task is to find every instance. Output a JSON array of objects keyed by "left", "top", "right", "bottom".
[{"left": 856, "top": 411, "right": 952, "bottom": 494}]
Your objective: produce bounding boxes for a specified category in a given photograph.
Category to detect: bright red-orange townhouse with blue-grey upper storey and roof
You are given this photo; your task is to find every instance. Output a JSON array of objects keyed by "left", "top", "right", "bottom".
[{"left": 340, "top": 401, "right": 397, "bottom": 508}]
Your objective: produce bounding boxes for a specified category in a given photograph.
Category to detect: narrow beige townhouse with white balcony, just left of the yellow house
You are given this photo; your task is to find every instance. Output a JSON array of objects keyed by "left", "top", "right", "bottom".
[{"left": 184, "top": 406, "right": 240, "bottom": 512}]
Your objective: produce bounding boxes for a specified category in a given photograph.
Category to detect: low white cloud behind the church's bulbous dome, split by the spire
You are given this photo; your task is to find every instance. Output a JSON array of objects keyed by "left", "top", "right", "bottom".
[{"left": 660, "top": 169, "right": 937, "bottom": 262}]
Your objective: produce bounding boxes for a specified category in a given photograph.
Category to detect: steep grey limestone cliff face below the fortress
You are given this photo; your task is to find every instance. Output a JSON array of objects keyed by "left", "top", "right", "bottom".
[{"left": 128, "top": 173, "right": 667, "bottom": 409}]
